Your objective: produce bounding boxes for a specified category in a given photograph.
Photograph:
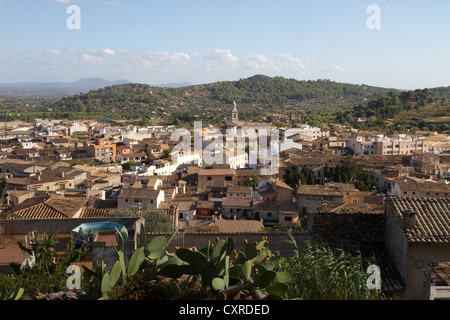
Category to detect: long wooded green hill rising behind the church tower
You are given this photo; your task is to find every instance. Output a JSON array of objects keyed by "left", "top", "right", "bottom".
[{"left": 42, "top": 75, "right": 392, "bottom": 119}]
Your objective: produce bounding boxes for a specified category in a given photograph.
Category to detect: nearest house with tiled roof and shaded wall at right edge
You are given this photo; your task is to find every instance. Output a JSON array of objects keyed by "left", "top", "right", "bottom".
[{"left": 385, "top": 196, "right": 450, "bottom": 300}]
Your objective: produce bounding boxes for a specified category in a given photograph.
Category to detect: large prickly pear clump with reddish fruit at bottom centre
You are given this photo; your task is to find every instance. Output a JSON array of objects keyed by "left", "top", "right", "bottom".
[{"left": 160, "top": 238, "right": 290, "bottom": 299}]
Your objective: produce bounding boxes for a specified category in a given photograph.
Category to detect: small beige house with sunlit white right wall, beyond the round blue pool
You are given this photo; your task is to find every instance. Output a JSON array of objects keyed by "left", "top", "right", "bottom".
[{"left": 117, "top": 188, "right": 164, "bottom": 210}]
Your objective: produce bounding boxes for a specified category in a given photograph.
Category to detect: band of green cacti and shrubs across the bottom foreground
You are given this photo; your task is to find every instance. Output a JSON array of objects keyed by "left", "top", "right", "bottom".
[{"left": 0, "top": 225, "right": 385, "bottom": 300}]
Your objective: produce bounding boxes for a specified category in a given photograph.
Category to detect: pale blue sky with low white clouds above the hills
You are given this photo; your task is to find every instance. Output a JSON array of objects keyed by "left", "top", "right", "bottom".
[{"left": 0, "top": 0, "right": 450, "bottom": 89}]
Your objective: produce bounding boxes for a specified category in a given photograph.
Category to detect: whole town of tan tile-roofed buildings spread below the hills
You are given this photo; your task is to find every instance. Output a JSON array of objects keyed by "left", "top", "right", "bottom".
[{"left": 0, "top": 104, "right": 450, "bottom": 299}]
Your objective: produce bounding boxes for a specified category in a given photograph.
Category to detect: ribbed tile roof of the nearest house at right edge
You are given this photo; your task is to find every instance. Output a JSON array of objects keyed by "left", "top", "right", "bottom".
[{"left": 387, "top": 197, "right": 450, "bottom": 243}]
